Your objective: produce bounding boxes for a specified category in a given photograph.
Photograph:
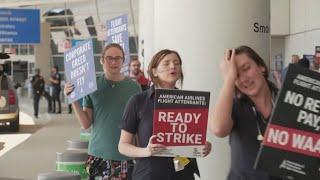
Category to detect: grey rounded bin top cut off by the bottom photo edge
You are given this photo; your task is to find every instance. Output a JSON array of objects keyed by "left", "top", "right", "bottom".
[{"left": 38, "top": 171, "right": 81, "bottom": 180}]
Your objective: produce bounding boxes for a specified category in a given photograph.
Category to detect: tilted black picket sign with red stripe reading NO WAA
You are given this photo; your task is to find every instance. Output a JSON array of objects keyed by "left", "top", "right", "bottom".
[{"left": 255, "top": 64, "right": 320, "bottom": 180}]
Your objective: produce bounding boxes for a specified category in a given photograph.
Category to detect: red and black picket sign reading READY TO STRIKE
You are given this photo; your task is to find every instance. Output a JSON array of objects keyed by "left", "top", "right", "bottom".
[{"left": 153, "top": 89, "right": 210, "bottom": 157}]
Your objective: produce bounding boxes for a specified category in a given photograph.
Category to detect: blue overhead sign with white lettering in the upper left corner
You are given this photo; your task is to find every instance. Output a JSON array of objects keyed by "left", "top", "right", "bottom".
[{"left": 0, "top": 8, "right": 40, "bottom": 44}]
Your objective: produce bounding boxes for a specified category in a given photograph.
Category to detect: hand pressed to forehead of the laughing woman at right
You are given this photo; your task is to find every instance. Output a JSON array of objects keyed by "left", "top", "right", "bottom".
[{"left": 220, "top": 49, "right": 238, "bottom": 81}]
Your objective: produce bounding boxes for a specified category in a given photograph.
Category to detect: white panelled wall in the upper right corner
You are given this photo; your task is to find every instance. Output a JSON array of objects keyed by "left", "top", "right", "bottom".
[{"left": 285, "top": 0, "right": 320, "bottom": 59}]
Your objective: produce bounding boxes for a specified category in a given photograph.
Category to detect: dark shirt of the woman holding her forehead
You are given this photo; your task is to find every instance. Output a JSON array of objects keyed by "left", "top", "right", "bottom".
[{"left": 228, "top": 97, "right": 281, "bottom": 180}]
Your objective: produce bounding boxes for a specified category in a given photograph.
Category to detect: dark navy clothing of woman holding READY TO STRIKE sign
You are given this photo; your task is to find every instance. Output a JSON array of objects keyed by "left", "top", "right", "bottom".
[{"left": 122, "top": 87, "right": 199, "bottom": 180}]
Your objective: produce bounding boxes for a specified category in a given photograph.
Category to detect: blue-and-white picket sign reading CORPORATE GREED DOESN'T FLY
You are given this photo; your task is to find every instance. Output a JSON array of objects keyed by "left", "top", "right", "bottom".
[{"left": 64, "top": 40, "right": 97, "bottom": 103}]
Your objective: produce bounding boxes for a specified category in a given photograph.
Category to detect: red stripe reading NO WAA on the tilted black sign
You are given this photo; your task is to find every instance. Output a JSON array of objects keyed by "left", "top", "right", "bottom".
[{"left": 263, "top": 124, "right": 320, "bottom": 158}]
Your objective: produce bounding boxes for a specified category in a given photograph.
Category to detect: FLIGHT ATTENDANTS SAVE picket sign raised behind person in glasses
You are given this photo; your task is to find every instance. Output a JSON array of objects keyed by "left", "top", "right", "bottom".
[{"left": 107, "top": 14, "right": 130, "bottom": 73}]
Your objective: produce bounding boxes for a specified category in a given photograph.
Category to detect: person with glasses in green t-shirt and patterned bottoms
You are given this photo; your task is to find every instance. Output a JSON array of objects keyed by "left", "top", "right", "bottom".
[{"left": 64, "top": 43, "right": 141, "bottom": 180}]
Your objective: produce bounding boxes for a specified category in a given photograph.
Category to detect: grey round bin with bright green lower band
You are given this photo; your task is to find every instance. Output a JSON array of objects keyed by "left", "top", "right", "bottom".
[{"left": 56, "top": 150, "right": 88, "bottom": 179}]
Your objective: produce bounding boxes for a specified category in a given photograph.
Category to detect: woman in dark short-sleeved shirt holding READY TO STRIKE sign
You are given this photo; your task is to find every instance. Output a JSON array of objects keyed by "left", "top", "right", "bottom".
[{"left": 119, "top": 49, "right": 211, "bottom": 180}]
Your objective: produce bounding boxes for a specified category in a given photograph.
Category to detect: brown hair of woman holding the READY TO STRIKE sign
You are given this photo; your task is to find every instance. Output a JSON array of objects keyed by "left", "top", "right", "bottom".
[{"left": 148, "top": 49, "right": 183, "bottom": 85}]
